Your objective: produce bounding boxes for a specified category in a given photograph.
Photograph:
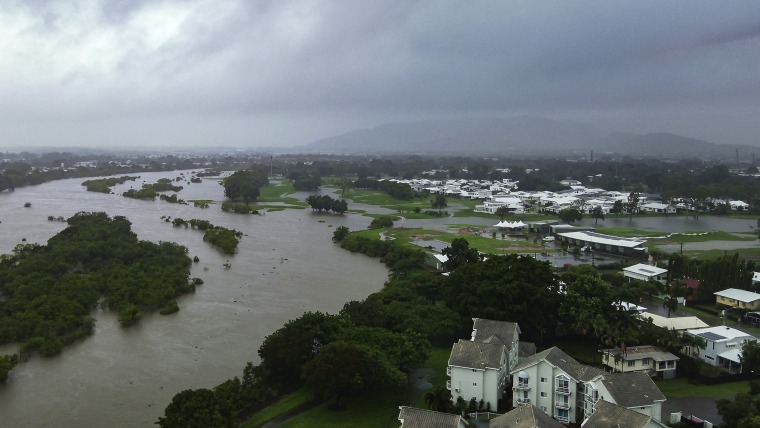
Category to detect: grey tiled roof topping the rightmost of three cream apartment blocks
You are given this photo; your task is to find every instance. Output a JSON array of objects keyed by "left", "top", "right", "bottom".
[{"left": 602, "top": 372, "right": 665, "bottom": 407}]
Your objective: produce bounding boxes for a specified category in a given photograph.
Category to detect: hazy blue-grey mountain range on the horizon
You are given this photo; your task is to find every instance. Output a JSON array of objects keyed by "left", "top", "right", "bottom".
[{"left": 308, "top": 116, "right": 760, "bottom": 160}]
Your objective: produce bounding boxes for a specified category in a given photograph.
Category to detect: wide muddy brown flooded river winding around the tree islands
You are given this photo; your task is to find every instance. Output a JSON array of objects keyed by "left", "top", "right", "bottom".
[{"left": 0, "top": 171, "right": 388, "bottom": 427}]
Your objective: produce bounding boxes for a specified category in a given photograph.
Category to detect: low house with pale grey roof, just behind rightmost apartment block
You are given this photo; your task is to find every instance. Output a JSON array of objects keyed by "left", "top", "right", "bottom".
[{"left": 601, "top": 345, "right": 679, "bottom": 379}]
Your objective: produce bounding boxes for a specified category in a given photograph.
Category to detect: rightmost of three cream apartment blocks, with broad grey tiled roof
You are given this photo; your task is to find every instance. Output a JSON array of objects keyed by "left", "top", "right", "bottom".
[{"left": 583, "top": 372, "right": 665, "bottom": 421}]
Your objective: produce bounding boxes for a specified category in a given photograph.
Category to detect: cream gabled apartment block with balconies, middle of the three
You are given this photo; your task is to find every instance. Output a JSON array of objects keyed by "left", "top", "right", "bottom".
[{"left": 510, "top": 347, "right": 603, "bottom": 424}]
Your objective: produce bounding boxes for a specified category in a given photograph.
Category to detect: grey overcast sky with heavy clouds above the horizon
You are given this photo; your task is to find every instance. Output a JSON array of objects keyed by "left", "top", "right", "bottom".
[{"left": 0, "top": 0, "right": 760, "bottom": 149}]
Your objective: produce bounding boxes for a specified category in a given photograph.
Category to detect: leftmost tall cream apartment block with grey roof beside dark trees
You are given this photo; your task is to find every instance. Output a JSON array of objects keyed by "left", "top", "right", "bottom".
[{"left": 447, "top": 318, "right": 520, "bottom": 410}]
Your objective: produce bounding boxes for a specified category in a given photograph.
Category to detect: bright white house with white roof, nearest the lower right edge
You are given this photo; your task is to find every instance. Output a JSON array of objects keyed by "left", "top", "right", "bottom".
[{"left": 684, "top": 326, "right": 757, "bottom": 370}]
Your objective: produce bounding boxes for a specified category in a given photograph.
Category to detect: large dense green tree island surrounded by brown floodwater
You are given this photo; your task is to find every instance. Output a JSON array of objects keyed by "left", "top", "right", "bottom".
[{"left": 0, "top": 212, "right": 195, "bottom": 376}]
